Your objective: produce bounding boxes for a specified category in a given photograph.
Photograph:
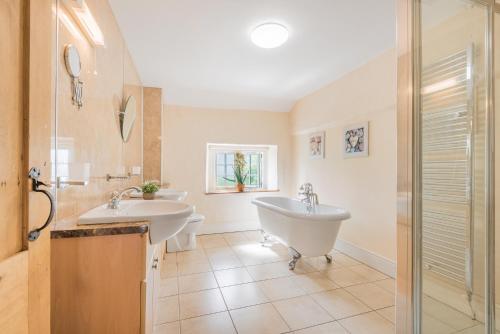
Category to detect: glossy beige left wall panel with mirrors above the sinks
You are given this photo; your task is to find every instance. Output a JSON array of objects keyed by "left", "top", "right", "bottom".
[{"left": 56, "top": 0, "right": 142, "bottom": 223}]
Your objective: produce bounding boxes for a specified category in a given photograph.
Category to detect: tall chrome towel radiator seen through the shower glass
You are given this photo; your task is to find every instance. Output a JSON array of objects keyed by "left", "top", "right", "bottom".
[{"left": 421, "top": 46, "right": 474, "bottom": 299}]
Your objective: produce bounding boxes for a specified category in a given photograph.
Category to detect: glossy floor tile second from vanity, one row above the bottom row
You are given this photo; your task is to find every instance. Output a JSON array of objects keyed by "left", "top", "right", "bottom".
[{"left": 179, "top": 289, "right": 226, "bottom": 319}]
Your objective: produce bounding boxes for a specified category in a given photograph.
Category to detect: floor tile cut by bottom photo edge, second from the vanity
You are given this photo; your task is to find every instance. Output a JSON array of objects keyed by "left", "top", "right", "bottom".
[{"left": 181, "top": 312, "right": 236, "bottom": 334}]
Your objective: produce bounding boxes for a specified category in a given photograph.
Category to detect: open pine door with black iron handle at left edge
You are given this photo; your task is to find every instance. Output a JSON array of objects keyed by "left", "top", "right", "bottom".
[{"left": 0, "top": 0, "right": 53, "bottom": 334}]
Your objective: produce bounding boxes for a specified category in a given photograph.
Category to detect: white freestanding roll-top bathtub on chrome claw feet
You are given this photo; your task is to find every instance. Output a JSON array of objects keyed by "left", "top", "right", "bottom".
[{"left": 252, "top": 197, "right": 351, "bottom": 270}]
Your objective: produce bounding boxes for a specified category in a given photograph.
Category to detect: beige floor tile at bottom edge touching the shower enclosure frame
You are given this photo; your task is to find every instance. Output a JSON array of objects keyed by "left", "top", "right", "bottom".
[{"left": 340, "top": 312, "right": 396, "bottom": 334}]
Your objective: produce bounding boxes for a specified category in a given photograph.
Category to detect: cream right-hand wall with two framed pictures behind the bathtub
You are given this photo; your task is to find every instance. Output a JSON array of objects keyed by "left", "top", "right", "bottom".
[{"left": 290, "top": 50, "right": 397, "bottom": 261}]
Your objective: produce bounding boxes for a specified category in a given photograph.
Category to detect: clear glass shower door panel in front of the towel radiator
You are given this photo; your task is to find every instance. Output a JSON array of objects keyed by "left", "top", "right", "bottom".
[{"left": 415, "top": 0, "right": 489, "bottom": 333}]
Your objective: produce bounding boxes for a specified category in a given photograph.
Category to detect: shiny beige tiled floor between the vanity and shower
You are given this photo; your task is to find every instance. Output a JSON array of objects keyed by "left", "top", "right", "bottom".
[{"left": 154, "top": 232, "right": 394, "bottom": 334}]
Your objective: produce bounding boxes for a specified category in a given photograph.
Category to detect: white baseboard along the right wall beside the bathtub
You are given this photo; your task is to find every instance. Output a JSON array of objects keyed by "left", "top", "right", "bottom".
[{"left": 335, "top": 239, "right": 396, "bottom": 278}]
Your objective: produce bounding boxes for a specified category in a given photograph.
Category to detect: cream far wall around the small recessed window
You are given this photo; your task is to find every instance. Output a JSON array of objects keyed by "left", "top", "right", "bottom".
[{"left": 162, "top": 105, "right": 291, "bottom": 233}]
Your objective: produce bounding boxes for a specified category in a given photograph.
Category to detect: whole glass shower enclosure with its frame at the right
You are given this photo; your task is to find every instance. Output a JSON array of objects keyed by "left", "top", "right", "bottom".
[{"left": 396, "top": 0, "right": 500, "bottom": 334}]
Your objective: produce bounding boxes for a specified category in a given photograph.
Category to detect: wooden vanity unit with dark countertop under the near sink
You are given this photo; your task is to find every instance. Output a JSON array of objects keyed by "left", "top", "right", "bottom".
[{"left": 51, "top": 222, "right": 163, "bottom": 334}]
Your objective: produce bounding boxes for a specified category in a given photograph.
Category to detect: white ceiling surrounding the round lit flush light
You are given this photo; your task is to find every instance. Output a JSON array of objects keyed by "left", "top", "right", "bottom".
[{"left": 110, "top": 0, "right": 396, "bottom": 111}]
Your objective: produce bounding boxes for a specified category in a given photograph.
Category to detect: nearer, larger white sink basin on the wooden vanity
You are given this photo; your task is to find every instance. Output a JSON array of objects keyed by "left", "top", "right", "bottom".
[{"left": 78, "top": 200, "right": 194, "bottom": 244}]
